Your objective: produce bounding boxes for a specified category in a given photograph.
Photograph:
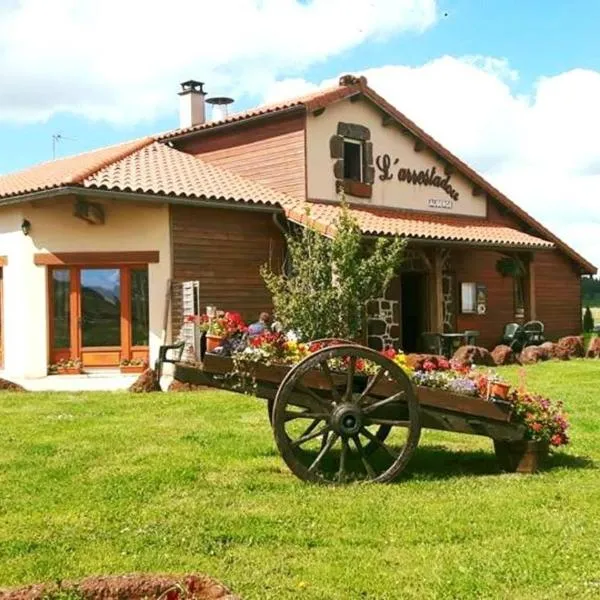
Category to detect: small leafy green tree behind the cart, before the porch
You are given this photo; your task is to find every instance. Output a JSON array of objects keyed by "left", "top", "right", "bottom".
[{"left": 261, "top": 201, "right": 405, "bottom": 340}]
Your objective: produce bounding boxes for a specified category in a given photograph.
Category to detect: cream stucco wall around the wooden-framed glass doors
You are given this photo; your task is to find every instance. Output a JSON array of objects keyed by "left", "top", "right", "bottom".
[{"left": 0, "top": 199, "right": 171, "bottom": 378}]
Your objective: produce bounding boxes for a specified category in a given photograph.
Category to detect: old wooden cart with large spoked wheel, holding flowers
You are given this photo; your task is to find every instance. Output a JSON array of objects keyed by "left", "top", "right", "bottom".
[{"left": 175, "top": 343, "right": 525, "bottom": 483}]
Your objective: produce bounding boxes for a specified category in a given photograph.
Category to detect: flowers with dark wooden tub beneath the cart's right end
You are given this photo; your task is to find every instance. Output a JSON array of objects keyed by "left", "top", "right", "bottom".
[{"left": 494, "top": 390, "right": 569, "bottom": 473}]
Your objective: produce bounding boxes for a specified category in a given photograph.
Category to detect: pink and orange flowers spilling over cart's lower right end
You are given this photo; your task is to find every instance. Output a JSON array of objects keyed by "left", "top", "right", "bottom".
[{"left": 510, "top": 390, "right": 569, "bottom": 446}]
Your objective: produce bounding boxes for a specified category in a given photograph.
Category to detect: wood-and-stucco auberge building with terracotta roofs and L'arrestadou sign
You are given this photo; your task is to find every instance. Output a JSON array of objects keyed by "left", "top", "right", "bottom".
[{"left": 0, "top": 76, "right": 596, "bottom": 377}]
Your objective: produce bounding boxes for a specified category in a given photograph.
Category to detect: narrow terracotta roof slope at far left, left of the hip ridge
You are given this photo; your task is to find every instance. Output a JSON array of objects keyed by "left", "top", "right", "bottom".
[{"left": 0, "top": 138, "right": 153, "bottom": 198}]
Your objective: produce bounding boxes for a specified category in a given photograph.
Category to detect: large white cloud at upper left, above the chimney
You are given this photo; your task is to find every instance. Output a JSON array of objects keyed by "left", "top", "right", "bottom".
[{"left": 0, "top": 0, "right": 436, "bottom": 122}]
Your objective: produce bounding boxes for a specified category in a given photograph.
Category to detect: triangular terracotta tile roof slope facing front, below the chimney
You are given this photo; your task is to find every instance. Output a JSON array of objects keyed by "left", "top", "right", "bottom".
[{"left": 83, "top": 142, "right": 296, "bottom": 206}]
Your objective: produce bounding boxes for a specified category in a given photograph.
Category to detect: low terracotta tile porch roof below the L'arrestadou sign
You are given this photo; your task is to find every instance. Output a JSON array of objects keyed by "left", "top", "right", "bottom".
[{"left": 286, "top": 202, "right": 554, "bottom": 248}]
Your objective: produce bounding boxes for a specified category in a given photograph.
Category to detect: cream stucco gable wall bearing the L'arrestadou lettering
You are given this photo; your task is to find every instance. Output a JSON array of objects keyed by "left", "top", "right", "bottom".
[{"left": 306, "top": 99, "right": 486, "bottom": 217}]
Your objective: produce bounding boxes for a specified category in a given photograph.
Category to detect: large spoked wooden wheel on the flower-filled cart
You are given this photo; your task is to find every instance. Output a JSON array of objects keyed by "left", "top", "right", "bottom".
[{"left": 271, "top": 345, "right": 421, "bottom": 483}]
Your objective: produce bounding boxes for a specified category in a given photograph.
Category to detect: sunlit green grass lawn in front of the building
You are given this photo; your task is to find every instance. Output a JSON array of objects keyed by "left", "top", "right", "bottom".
[{"left": 0, "top": 361, "right": 600, "bottom": 600}]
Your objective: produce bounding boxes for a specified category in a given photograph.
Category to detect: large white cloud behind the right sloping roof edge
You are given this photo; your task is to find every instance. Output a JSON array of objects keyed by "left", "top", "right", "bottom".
[{"left": 267, "top": 56, "right": 600, "bottom": 266}]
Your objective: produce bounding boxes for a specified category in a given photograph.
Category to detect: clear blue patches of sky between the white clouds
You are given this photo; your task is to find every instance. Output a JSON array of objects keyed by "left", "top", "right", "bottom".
[{"left": 0, "top": 0, "right": 600, "bottom": 173}]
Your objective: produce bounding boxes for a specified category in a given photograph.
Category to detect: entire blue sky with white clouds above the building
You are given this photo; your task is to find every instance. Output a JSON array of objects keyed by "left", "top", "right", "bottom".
[{"left": 0, "top": 0, "right": 600, "bottom": 266}]
